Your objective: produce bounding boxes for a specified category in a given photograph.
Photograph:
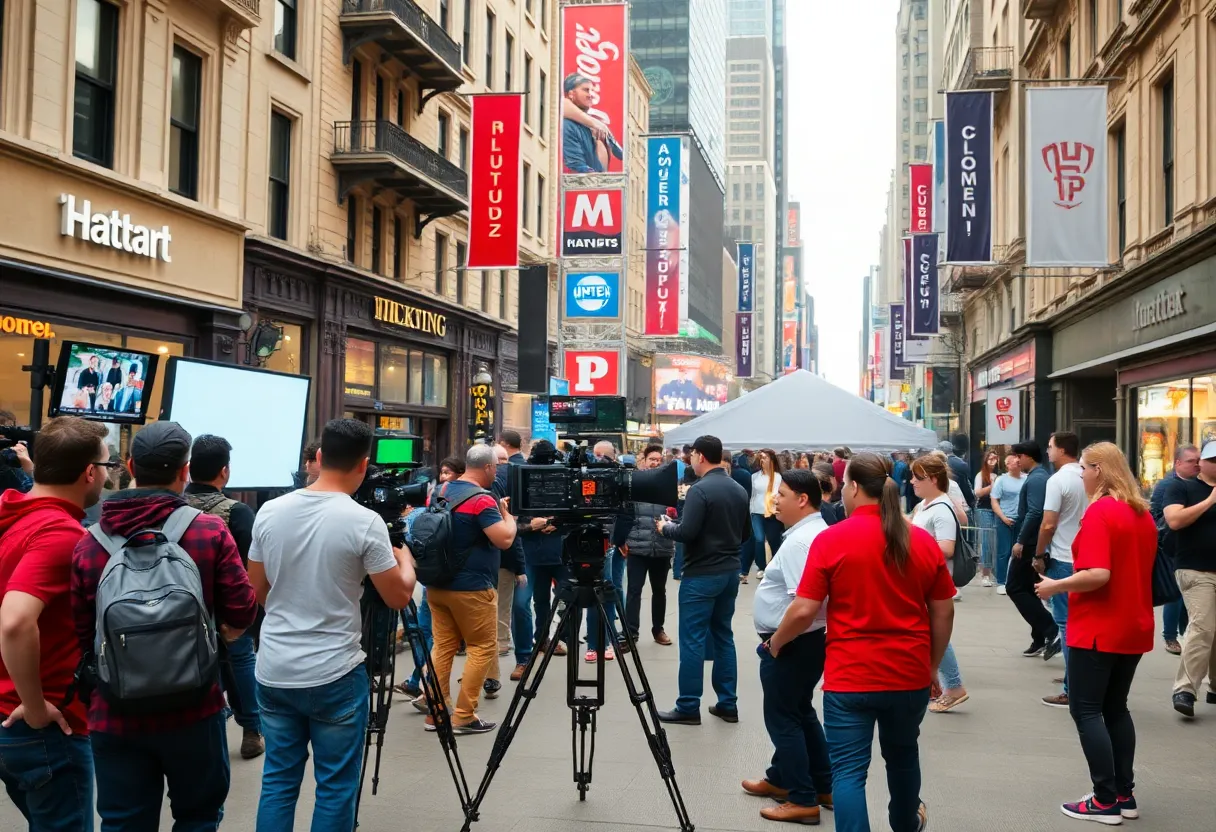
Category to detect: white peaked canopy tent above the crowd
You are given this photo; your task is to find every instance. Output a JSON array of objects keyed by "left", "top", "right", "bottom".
[{"left": 663, "top": 370, "right": 939, "bottom": 451}]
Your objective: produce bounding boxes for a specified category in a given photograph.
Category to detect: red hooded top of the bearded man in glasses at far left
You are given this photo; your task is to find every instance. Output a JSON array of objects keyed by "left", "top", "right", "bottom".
[{"left": 0, "top": 490, "right": 89, "bottom": 736}]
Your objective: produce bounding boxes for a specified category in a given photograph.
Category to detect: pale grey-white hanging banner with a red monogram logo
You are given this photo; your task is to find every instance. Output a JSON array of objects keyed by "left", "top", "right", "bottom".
[{"left": 1026, "top": 86, "right": 1110, "bottom": 266}]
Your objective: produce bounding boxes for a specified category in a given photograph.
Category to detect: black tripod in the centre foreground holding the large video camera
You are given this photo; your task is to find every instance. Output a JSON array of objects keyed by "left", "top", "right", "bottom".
[{"left": 462, "top": 525, "right": 696, "bottom": 832}]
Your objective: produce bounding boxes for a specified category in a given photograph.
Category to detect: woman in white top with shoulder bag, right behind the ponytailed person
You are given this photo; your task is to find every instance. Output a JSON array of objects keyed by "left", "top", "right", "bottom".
[{"left": 912, "top": 451, "right": 970, "bottom": 714}]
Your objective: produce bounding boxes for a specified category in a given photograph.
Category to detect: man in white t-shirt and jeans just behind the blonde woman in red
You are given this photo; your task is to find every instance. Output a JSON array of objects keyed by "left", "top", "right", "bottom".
[{"left": 1035, "top": 431, "right": 1090, "bottom": 708}]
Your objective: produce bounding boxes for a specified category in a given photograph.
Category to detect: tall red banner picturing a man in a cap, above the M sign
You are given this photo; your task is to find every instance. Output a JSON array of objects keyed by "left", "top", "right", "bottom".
[{"left": 559, "top": 2, "right": 629, "bottom": 174}]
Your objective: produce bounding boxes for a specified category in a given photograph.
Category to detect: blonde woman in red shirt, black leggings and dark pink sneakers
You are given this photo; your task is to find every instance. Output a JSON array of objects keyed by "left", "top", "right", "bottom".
[{"left": 1035, "top": 442, "right": 1156, "bottom": 826}]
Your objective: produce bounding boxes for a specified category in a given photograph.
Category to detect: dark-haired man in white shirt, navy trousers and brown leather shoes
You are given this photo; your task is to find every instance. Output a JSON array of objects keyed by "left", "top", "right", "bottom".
[{"left": 743, "top": 468, "right": 832, "bottom": 823}]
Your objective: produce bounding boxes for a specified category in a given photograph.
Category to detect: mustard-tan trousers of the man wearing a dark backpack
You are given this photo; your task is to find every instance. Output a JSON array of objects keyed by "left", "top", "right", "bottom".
[{"left": 427, "top": 586, "right": 499, "bottom": 725}]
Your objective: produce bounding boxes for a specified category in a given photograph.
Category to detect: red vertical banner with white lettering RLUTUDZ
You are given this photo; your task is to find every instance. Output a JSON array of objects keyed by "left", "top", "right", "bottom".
[{"left": 466, "top": 94, "right": 523, "bottom": 269}]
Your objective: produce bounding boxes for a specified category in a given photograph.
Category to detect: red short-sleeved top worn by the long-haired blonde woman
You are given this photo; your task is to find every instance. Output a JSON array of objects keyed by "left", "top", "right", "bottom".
[{"left": 1068, "top": 496, "right": 1156, "bottom": 654}]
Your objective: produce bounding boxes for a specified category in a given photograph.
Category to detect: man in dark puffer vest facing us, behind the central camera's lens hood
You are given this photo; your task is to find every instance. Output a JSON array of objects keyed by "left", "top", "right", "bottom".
[{"left": 612, "top": 445, "right": 676, "bottom": 646}]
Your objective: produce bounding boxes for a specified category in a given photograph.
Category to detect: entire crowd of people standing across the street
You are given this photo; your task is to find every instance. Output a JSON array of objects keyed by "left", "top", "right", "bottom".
[{"left": 0, "top": 416, "right": 1216, "bottom": 832}]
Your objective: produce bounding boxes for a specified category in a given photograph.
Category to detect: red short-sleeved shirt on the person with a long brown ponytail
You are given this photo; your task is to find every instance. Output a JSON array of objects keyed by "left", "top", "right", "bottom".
[{"left": 798, "top": 506, "right": 958, "bottom": 693}]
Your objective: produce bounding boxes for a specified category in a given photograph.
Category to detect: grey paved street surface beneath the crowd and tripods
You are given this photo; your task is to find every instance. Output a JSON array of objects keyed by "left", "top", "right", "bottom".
[{"left": 0, "top": 579, "right": 1216, "bottom": 832}]
